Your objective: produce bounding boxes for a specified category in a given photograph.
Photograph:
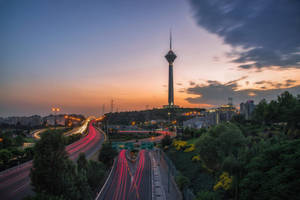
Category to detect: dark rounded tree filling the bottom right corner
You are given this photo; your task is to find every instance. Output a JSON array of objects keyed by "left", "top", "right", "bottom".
[{"left": 241, "top": 139, "right": 300, "bottom": 200}]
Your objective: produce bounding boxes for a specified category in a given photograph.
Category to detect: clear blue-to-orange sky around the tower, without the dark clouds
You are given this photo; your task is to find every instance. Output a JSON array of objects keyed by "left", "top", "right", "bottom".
[{"left": 0, "top": 0, "right": 300, "bottom": 116}]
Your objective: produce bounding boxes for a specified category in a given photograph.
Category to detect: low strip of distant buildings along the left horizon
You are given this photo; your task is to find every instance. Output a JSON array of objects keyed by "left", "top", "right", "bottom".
[{"left": 0, "top": 114, "right": 84, "bottom": 127}]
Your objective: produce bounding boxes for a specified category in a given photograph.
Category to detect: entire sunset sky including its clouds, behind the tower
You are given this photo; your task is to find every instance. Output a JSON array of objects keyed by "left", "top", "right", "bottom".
[{"left": 0, "top": 0, "right": 300, "bottom": 116}]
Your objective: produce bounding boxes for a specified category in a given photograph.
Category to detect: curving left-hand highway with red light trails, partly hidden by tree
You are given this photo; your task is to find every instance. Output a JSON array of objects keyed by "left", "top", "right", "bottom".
[{"left": 0, "top": 121, "right": 104, "bottom": 200}]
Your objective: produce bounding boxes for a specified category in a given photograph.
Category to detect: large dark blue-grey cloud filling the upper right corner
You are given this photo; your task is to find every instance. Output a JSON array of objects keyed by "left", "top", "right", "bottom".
[{"left": 189, "top": 0, "right": 300, "bottom": 69}]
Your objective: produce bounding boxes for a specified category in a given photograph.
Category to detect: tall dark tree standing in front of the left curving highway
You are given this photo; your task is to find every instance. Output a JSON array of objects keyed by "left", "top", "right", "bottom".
[{"left": 30, "top": 132, "right": 76, "bottom": 196}]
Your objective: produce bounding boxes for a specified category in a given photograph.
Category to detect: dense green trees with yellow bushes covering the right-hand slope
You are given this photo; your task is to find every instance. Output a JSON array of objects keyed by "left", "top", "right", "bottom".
[{"left": 162, "top": 92, "right": 300, "bottom": 200}]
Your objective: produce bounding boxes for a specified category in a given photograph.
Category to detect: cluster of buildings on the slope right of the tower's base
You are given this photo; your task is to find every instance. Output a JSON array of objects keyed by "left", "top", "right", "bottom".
[{"left": 183, "top": 104, "right": 237, "bottom": 128}]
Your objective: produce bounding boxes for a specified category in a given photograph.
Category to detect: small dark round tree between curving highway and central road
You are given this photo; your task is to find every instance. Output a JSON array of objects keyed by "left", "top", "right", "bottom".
[{"left": 98, "top": 142, "right": 118, "bottom": 166}]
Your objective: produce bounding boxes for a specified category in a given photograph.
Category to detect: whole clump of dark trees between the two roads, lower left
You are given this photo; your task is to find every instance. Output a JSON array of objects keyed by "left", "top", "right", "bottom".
[{"left": 27, "top": 132, "right": 108, "bottom": 200}]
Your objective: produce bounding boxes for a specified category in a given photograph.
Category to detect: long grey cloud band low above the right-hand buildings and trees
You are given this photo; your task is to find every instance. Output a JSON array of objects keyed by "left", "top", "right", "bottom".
[{"left": 186, "top": 80, "right": 300, "bottom": 105}]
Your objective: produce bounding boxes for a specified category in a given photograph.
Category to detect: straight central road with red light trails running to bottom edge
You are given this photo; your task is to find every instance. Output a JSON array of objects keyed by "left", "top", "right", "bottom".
[{"left": 96, "top": 150, "right": 152, "bottom": 200}]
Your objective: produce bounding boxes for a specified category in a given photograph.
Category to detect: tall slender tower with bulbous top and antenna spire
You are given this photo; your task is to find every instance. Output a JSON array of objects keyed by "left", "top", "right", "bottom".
[{"left": 165, "top": 31, "right": 177, "bottom": 108}]
